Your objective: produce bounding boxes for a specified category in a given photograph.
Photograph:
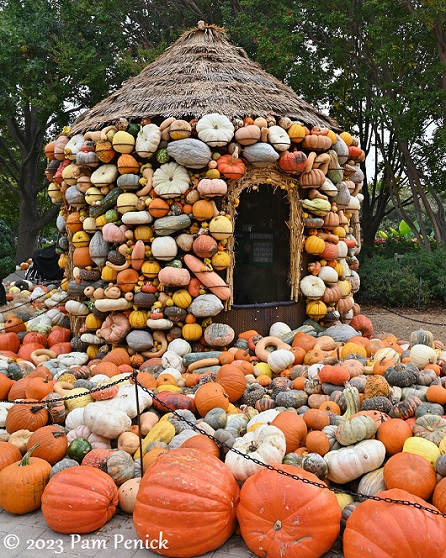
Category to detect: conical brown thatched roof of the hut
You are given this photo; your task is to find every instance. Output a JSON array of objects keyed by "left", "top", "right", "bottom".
[{"left": 71, "top": 22, "right": 337, "bottom": 134}]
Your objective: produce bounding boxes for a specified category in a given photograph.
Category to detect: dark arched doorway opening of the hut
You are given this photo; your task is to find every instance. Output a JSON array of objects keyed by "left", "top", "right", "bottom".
[{"left": 233, "top": 184, "right": 290, "bottom": 306}]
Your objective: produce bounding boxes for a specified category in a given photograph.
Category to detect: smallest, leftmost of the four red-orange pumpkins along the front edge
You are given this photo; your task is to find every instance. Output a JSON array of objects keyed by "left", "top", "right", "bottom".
[{"left": 42, "top": 465, "right": 118, "bottom": 533}]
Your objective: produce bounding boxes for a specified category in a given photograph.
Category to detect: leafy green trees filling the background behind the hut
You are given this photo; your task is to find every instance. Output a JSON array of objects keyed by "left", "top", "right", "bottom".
[{"left": 0, "top": 0, "right": 446, "bottom": 261}]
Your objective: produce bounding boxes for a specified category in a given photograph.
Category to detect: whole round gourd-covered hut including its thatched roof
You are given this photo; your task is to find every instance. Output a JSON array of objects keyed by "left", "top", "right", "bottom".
[{"left": 46, "top": 22, "right": 364, "bottom": 356}]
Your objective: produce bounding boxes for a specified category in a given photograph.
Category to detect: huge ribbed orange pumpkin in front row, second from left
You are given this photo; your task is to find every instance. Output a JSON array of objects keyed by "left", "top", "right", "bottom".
[{"left": 133, "top": 448, "right": 239, "bottom": 558}]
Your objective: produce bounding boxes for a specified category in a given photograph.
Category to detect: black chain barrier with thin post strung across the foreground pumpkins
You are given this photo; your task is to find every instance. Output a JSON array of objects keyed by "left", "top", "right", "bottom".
[{"left": 3, "top": 364, "right": 446, "bottom": 518}]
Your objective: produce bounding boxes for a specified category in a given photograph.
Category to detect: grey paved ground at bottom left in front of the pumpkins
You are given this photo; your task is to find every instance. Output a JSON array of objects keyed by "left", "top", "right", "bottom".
[{"left": 0, "top": 508, "right": 251, "bottom": 558}]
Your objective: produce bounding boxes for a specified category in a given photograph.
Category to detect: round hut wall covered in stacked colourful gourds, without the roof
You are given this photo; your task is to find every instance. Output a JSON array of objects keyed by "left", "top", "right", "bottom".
[{"left": 45, "top": 113, "right": 364, "bottom": 357}]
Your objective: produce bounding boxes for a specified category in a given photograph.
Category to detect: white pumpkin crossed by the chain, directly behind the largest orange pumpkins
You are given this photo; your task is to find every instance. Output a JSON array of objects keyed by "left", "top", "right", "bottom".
[{"left": 225, "top": 425, "right": 286, "bottom": 482}]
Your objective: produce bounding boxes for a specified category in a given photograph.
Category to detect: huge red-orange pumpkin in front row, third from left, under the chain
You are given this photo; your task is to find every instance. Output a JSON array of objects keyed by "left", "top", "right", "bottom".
[{"left": 237, "top": 465, "right": 341, "bottom": 558}]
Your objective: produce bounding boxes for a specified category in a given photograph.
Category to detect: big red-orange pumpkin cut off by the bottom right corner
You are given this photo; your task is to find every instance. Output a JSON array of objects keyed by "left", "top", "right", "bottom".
[{"left": 343, "top": 488, "right": 446, "bottom": 558}]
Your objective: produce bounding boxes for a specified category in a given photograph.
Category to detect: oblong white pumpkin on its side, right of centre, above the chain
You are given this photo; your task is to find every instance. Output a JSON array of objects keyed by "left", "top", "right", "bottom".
[{"left": 324, "top": 440, "right": 386, "bottom": 484}]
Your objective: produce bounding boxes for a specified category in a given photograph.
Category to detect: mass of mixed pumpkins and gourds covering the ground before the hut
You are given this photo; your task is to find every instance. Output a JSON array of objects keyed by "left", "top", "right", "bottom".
[{"left": 0, "top": 314, "right": 446, "bottom": 558}]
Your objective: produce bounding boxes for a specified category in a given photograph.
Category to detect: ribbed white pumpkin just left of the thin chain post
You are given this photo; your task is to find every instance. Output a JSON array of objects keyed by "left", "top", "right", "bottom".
[{"left": 83, "top": 399, "right": 132, "bottom": 440}]
